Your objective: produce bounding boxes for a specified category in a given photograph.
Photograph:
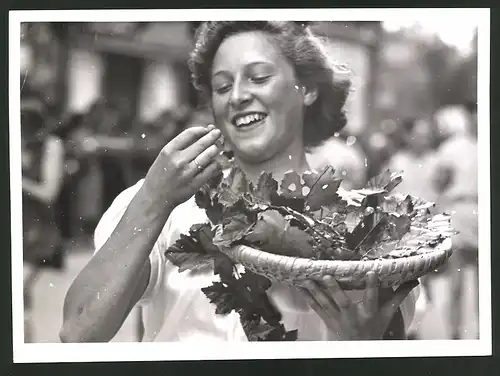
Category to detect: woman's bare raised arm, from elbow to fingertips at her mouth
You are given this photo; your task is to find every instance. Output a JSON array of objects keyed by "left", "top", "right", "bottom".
[{"left": 60, "top": 127, "right": 220, "bottom": 342}]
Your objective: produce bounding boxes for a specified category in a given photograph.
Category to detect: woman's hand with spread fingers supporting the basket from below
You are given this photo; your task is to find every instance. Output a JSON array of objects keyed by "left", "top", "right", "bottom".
[{"left": 304, "top": 272, "right": 419, "bottom": 340}]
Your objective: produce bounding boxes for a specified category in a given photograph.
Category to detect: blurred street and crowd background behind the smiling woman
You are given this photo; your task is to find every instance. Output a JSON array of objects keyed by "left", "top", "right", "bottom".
[{"left": 20, "top": 20, "right": 480, "bottom": 342}]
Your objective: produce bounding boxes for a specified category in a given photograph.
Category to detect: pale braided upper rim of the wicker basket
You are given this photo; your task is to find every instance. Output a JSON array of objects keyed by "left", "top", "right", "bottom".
[{"left": 229, "top": 238, "right": 452, "bottom": 271}]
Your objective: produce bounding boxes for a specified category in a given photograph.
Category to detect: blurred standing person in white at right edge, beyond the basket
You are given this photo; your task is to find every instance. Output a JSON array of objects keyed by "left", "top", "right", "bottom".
[{"left": 433, "top": 101, "right": 479, "bottom": 339}]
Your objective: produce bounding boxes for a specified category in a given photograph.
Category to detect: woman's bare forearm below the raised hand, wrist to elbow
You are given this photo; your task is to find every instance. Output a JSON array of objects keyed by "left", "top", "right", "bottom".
[{"left": 60, "top": 187, "right": 172, "bottom": 342}]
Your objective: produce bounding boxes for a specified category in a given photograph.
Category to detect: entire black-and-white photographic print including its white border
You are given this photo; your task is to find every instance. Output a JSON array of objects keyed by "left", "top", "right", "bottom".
[{"left": 9, "top": 8, "right": 492, "bottom": 363}]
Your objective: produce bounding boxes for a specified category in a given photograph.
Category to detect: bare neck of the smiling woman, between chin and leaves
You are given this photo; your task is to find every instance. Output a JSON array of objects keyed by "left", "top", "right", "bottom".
[{"left": 235, "top": 141, "right": 309, "bottom": 182}]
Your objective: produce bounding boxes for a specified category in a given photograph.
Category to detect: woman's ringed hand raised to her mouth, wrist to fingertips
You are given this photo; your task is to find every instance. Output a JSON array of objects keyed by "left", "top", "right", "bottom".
[{"left": 143, "top": 125, "right": 221, "bottom": 208}]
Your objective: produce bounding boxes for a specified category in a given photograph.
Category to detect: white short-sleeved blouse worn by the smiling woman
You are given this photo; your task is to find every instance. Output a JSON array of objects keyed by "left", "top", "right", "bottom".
[{"left": 94, "top": 180, "right": 419, "bottom": 342}]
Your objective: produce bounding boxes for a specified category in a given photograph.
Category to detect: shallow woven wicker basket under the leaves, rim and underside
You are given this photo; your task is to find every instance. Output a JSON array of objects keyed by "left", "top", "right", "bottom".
[{"left": 224, "top": 238, "right": 453, "bottom": 290}]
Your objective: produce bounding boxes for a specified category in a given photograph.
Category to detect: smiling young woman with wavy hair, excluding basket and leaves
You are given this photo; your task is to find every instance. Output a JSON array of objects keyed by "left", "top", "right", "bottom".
[{"left": 60, "top": 22, "right": 417, "bottom": 342}]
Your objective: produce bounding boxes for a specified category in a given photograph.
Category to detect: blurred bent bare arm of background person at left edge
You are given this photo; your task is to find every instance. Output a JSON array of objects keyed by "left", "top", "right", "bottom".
[{"left": 22, "top": 136, "right": 64, "bottom": 205}]
